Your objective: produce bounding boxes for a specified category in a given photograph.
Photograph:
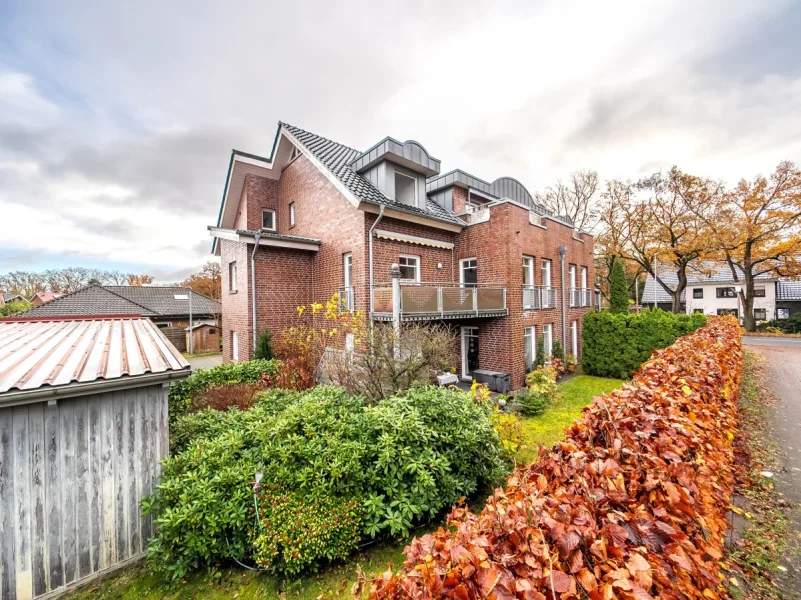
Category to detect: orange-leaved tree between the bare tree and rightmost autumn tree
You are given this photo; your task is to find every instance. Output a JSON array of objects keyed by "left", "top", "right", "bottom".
[{"left": 601, "top": 167, "right": 721, "bottom": 312}]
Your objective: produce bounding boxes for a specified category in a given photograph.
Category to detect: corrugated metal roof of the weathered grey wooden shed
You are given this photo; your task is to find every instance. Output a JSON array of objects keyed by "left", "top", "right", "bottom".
[{"left": 0, "top": 316, "right": 189, "bottom": 395}]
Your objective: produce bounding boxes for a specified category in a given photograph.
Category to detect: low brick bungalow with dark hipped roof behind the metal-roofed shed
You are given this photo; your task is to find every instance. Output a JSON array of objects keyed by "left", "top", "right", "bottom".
[{"left": 22, "top": 285, "right": 221, "bottom": 352}]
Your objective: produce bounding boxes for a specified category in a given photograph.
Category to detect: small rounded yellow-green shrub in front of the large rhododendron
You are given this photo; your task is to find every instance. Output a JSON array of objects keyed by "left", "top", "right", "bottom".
[{"left": 252, "top": 485, "right": 361, "bottom": 576}]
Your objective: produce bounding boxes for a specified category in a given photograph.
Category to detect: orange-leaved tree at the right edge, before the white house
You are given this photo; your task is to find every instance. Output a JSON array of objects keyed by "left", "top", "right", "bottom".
[{"left": 695, "top": 162, "right": 801, "bottom": 331}]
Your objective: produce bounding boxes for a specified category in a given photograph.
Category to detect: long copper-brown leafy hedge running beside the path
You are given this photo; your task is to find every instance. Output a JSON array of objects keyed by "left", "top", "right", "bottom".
[{"left": 372, "top": 317, "right": 742, "bottom": 600}]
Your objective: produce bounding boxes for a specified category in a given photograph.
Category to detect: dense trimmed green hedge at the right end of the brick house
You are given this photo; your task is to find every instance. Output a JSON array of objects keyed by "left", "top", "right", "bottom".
[{"left": 581, "top": 310, "right": 706, "bottom": 379}]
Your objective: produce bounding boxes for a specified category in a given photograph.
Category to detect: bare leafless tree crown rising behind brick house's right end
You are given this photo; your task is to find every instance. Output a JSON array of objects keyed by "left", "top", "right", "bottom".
[{"left": 536, "top": 170, "right": 598, "bottom": 231}]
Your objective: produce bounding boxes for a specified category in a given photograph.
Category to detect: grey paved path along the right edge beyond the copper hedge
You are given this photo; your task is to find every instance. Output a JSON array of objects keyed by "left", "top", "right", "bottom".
[{"left": 743, "top": 338, "right": 801, "bottom": 598}]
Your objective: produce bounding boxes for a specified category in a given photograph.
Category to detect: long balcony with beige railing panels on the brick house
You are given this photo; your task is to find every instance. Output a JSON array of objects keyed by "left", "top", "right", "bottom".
[{"left": 373, "top": 283, "right": 509, "bottom": 321}]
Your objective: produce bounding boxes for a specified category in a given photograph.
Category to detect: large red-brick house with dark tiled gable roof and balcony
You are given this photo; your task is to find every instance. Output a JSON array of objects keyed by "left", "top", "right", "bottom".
[{"left": 209, "top": 123, "right": 594, "bottom": 387}]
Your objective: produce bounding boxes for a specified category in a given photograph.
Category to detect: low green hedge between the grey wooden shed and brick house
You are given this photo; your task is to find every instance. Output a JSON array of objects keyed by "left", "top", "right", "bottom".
[{"left": 169, "top": 360, "right": 281, "bottom": 427}]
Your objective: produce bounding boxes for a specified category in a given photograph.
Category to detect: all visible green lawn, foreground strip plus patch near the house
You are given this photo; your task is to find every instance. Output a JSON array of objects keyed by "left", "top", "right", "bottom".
[{"left": 67, "top": 375, "right": 623, "bottom": 600}]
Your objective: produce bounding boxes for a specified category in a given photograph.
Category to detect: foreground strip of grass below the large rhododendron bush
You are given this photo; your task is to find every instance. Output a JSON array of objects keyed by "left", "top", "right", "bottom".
[{"left": 65, "top": 530, "right": 410, "bottom": 600}]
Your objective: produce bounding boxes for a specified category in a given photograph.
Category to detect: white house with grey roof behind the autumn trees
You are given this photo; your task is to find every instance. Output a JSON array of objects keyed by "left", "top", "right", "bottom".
[{"left": 641, "top": 263, "right": 784, "bottom": 321}]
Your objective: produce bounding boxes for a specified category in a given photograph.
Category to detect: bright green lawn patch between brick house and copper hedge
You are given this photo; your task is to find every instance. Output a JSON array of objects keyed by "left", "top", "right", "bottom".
[{"left": 515, "top": 375, "right": 623, "bottom": 464}]
